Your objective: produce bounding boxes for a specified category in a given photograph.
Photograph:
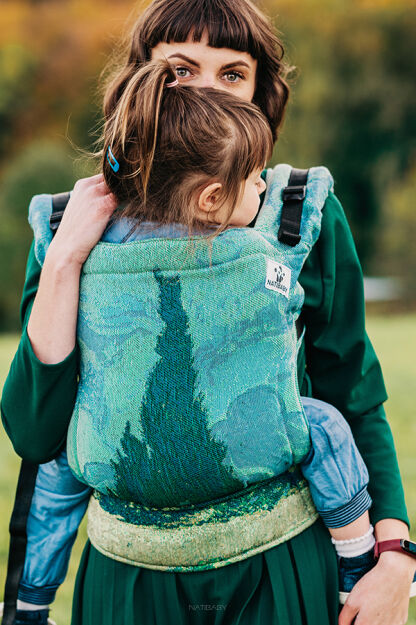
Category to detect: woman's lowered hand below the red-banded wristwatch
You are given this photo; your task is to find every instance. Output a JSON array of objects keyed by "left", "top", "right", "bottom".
[{"left": 338, "top": 551, "right": 416, "bottom": 625}]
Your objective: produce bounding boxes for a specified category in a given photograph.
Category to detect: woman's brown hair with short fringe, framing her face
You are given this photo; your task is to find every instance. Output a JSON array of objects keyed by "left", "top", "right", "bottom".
[{"left": 104, "top": 0, "right": 289, "bottom": 141}]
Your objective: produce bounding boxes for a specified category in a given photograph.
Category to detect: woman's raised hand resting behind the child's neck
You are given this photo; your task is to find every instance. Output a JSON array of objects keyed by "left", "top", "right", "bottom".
[{"left": 48, "top": 174, "right": 117, "bottom": 266}]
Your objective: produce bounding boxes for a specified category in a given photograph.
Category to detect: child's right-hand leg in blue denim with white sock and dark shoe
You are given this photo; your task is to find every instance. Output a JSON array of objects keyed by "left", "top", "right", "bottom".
[{"left": 301, "top": 397, "right": 375, "bottom": 602}]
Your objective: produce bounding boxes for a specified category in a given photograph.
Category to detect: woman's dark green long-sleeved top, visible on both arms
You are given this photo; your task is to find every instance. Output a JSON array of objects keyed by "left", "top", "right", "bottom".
[{"left": 1, "top": 193, "right": 409, "bottom": 523}]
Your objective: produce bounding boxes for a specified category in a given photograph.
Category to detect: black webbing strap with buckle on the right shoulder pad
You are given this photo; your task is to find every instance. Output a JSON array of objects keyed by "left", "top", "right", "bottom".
[{"left": 278, "top": 167, "right": 309, "bottom": 247}]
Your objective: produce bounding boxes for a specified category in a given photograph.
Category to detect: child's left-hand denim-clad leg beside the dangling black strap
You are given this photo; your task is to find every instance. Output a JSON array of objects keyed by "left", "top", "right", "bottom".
[{"left": 17, "top": 451, "right": 91, "bottom": 616}]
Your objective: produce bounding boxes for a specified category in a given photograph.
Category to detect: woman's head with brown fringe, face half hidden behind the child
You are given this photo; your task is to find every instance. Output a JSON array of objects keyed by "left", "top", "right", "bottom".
[{"left": 105, "top": 0, "right": 289, "bottom": 141}]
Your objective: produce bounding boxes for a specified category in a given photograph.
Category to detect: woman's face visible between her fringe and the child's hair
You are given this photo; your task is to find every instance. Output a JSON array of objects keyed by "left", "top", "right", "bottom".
[{"left": 152, "top": 34, "right": 257, "bottom": 102}]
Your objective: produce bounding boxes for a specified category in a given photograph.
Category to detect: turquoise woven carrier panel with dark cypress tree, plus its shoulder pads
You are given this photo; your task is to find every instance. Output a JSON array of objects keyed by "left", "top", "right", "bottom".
[{"left": 29, "top": 165, "right": 333, "bottom": 517}]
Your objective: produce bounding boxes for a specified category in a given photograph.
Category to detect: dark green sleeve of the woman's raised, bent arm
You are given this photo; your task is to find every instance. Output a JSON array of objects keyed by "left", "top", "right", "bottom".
[{"left": 1, "top": 242, "right": 79, "bottom": 464}]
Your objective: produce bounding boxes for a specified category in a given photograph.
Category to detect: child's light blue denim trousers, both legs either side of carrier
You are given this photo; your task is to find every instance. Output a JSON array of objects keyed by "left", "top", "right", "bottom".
[{"left": 19, "top": 397, "right": 371, "bottom": 605}]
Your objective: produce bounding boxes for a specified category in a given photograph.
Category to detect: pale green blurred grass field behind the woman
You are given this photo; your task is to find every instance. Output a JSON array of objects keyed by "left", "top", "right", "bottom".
[{"left": 0, "top": 315, "right": 416, "bottom": 625}]
